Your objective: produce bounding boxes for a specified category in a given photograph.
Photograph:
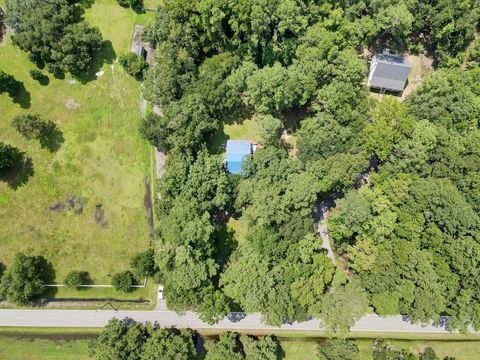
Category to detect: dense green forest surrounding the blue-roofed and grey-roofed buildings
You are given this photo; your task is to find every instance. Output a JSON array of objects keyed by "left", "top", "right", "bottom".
[{"left": 141, "top": 0, "right": 480, "bottom": 331}]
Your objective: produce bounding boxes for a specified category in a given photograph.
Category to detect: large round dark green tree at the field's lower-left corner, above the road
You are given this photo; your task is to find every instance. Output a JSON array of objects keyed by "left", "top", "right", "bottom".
[{"left": 0, "top": 253, "right": 52, "bottom": 305}]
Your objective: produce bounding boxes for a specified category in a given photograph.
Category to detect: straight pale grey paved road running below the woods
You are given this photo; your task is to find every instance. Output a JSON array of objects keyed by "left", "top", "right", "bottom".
[{"left": 0, "top": 310, "right": 462, "bottom": 333}]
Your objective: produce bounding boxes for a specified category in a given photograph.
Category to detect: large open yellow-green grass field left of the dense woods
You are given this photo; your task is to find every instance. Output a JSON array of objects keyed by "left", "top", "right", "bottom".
[{"left": 0, "top": 0, "right": 150, "bottom": 283}]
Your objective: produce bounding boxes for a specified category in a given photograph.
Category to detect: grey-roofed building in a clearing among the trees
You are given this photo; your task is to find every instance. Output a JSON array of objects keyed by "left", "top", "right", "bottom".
[{"left": 368, "top": 49, "right": 412, "bottom": 93}]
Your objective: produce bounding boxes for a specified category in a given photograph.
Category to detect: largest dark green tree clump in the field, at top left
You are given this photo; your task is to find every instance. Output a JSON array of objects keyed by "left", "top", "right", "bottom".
[{"left": 6, "top": 0, "right": 103, "bottom": 76}]
